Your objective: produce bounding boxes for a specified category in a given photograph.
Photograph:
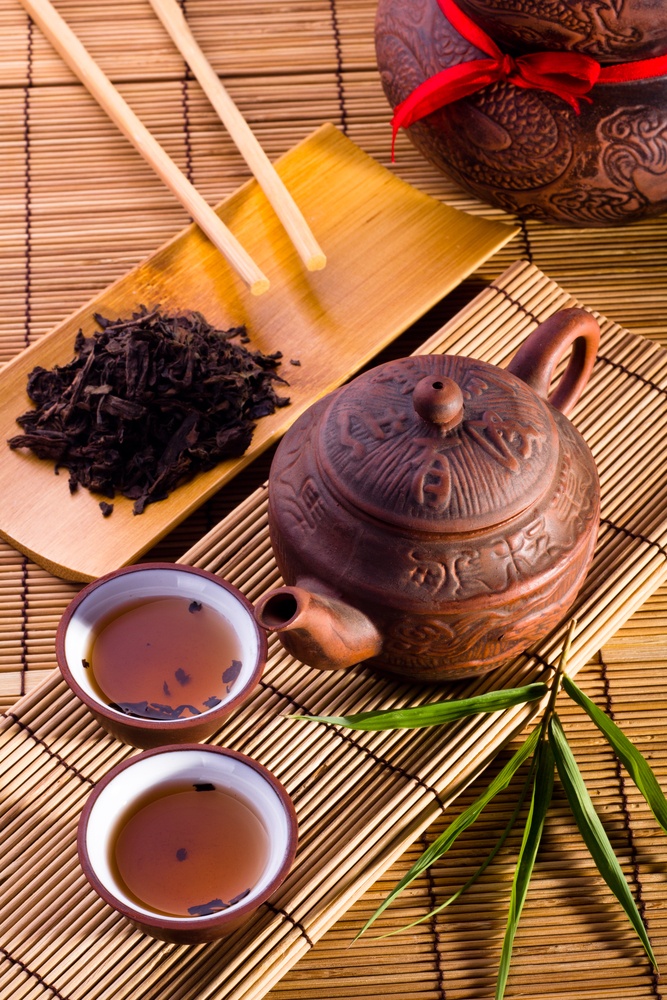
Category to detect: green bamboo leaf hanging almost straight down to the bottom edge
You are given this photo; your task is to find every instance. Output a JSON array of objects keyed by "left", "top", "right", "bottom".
[{"left": 496, "top": 740, "right": 554, "bottom": 1000}]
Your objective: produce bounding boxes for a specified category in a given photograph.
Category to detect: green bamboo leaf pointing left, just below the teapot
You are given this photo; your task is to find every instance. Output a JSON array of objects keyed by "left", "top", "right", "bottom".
[{"left": 289, "top": 681, "right": 548, "bottom": 731}]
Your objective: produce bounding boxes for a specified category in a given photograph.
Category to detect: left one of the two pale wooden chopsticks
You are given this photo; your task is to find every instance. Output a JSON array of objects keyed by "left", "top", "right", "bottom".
[{"left": 20, "top": 0, "right": 269, "bottom": 295}]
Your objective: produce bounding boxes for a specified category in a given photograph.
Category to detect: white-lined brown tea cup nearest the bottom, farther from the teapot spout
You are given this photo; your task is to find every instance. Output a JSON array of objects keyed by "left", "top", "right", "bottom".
[{"left": 77, "top": 743, "right": 297, "bottom": 944}]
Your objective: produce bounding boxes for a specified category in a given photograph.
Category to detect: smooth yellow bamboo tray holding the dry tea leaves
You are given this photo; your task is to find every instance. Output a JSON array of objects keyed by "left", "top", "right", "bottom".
[{"left": 0, "top": 125, "right": 516, "bottom": 580}]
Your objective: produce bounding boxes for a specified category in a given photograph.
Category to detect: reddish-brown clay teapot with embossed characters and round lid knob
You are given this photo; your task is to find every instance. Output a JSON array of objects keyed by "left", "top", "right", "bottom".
[{"left": 255, "top": 309, "right": 599, "bottom": 681}]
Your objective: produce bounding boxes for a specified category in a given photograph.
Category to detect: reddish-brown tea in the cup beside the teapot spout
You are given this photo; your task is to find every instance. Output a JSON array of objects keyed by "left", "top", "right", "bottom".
[{"left": 84, "top": 597, "right": 241, "bottom": 719}]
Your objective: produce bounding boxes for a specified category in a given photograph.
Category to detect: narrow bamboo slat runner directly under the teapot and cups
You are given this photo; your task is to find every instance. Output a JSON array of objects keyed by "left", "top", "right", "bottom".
[{"left": 0, "top": 262, "right": 667, "bottom": 1000}]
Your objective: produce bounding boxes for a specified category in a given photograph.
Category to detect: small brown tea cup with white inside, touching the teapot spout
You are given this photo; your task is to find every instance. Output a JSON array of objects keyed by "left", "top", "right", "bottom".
[{"left": 56, "top": 563, "right": 266, "bottom": 749}]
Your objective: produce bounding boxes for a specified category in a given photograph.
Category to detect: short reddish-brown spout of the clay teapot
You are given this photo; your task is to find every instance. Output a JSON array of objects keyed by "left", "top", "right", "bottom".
[{"left": 255, "top": 587, "right": 382, "bottom": 670}]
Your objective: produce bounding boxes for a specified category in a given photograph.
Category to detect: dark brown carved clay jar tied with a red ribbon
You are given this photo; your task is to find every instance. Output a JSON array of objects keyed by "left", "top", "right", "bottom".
[{"left": 376, "top": 0, "right": 667, "bottom": 226}]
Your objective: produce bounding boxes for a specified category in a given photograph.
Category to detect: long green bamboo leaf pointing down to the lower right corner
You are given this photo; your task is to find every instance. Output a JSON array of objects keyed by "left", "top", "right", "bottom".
[{"left": 549, "top": 713, "right": 657, "bottom": 970}]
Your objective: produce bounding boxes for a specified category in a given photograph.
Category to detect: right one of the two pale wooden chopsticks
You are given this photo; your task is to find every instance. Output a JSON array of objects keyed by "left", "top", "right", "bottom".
[{"left": 150, "top": 0, "right": 326, "bottom": 271}]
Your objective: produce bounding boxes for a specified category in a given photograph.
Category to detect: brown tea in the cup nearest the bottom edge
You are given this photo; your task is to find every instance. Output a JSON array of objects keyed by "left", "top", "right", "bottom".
[{"left": 112, "top": 784, "right": 269, "bottom": 917}]
